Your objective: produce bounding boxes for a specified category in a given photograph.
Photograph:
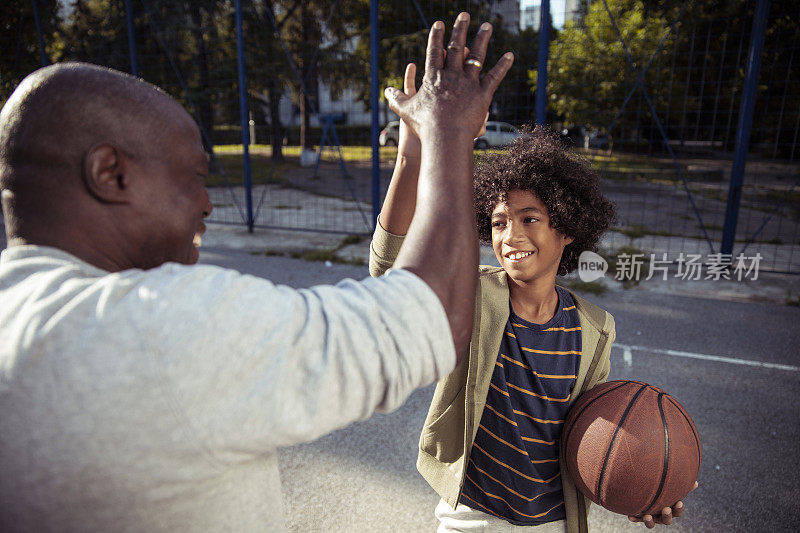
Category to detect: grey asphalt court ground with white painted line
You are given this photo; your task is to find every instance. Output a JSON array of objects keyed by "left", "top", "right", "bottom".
[{"left": 194, "top": 250, "right": 800, "bottom": 533}]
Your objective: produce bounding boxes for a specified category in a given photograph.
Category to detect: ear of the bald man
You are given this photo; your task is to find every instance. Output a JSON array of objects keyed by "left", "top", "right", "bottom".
[{"left": 83, "top": 143, "right": 130, "bottom": 204}]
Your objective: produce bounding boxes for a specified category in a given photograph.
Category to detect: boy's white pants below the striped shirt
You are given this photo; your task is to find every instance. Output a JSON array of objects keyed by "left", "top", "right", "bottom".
[{"left": 435, "top": 500, "right": 567, "bottom": 533}]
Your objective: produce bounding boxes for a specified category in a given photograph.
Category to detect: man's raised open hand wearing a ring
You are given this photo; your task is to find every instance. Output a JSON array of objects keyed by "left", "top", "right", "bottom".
[{"left": 386, "top": 13, "right": 513, "bottom": 148}]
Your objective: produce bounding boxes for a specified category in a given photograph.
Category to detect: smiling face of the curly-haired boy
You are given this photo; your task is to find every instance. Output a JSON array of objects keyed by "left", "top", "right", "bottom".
[{"left": 491, "top": 190, "right": 573, "bottom": 283}]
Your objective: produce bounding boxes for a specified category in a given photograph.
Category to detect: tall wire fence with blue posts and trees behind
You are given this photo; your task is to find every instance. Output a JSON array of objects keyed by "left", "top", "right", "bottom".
[{"left": 0, "top": 0, "right": 800, "bottom": 274}]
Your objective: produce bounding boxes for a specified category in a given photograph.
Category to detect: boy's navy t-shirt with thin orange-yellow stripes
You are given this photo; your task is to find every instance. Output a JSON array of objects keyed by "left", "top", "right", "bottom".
[{"left": 459, "top": 287, "right": 581, "bottom": 525}]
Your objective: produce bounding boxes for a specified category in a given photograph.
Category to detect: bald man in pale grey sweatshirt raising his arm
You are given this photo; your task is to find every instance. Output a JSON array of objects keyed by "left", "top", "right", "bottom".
[{"left": 0, "top": 14, "right": 511, "bottom": 531}]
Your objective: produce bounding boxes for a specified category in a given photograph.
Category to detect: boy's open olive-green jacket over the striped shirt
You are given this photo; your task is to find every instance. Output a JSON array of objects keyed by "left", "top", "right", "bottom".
[{"left": 369, "top": 225, "right": 616, "bottom": 533}]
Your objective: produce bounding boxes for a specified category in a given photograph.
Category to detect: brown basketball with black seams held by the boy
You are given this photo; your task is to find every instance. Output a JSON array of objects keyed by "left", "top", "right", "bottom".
[{"left": 561, "top": 380, "right": 702, "bottom": 517}]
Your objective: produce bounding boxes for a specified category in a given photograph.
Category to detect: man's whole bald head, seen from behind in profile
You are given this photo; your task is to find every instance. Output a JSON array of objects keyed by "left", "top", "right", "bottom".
[{"left": 0, "top": 63, "right": 212, "bottom": 271}]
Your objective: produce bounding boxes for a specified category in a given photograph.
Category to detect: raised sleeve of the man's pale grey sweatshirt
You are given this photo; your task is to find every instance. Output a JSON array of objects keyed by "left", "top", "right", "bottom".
[{"left": 134, "top": 265, "right": 455, "bottom": 460}]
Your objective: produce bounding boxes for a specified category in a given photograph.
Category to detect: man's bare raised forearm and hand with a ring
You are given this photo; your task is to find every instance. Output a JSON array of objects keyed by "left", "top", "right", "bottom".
[{"left": 386, "top": 13, "right": 513, "bottom": 357}]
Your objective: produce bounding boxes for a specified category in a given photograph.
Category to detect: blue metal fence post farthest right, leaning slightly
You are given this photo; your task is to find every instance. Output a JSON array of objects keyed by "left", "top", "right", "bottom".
[{"left": 720, "top": 0, "right": 770, "bottom": 254}]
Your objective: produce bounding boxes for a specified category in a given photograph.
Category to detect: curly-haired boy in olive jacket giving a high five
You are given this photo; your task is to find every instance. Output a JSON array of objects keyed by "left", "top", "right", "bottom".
[{"left": 370, "top": 65, "right": 683, "bottom": 533}]
